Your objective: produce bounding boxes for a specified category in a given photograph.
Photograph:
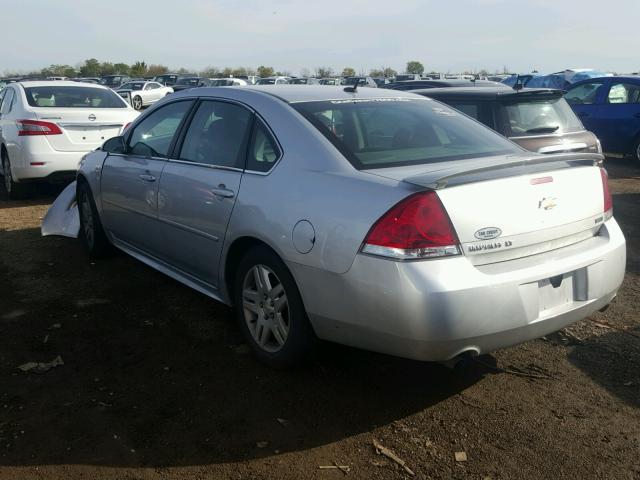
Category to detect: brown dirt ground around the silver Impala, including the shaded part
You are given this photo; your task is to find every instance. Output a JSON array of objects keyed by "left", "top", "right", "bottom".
[{"left": 0, "top": 160, "right": 640, "bottom": 480}]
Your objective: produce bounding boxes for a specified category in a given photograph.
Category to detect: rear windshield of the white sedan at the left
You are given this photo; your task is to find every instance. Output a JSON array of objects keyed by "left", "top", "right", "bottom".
[{"left": 24, "top": 86, "right": 128, "bottom": 108}]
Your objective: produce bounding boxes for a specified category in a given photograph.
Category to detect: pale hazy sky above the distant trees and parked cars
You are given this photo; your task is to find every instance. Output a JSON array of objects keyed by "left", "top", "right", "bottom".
[{"left": 0, "top": 0, "right": 640, "bottom": 74}]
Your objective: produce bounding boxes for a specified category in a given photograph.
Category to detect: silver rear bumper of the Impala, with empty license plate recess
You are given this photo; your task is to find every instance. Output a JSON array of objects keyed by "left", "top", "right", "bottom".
[{"left": 290, "top": 219, "right": 626, "bottom": 361}]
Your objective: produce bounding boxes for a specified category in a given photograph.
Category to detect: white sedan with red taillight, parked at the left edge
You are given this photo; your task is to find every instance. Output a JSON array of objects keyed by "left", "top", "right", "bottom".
[{"left": 0, "top": 81, "right": 138, "bottom": 198}]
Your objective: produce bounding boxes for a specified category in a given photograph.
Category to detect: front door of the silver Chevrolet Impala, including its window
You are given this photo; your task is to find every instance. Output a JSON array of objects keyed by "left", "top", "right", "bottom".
[{"left": 100, "top": 99, "right": 193, "bottom": 256}]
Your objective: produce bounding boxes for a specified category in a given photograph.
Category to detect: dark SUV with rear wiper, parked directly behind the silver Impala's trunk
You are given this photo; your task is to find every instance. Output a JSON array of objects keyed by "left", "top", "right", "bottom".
[{"left": 412, "top": 87, "right": 602, "bottom": 153}]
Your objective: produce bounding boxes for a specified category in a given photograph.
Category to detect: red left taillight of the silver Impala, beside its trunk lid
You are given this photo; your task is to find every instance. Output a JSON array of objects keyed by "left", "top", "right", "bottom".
[{"left": 362, "top": 191, "right": 460, "bottom": 260}]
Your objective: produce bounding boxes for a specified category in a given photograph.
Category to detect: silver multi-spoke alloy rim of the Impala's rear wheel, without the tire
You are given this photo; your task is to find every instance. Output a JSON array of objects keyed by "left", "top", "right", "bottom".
[{"left": 242, "top": 265, "right": 291, "bottom": 353}]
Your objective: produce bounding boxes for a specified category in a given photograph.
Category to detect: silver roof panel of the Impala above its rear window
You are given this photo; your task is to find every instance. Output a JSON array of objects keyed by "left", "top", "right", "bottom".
[{"left": 235, "top": 84, "right": 416, "bottom": 103}]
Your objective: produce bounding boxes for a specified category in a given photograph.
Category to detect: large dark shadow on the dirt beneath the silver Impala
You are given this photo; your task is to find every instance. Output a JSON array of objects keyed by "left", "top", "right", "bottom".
[{"left": 0, "top": 229, "right": 488, "bottom": 467}]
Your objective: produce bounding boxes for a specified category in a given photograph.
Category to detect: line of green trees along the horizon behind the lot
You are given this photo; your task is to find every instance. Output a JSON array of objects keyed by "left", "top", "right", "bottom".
[{"left": 6, "top": 58, "right": 432, "bottom": 78}]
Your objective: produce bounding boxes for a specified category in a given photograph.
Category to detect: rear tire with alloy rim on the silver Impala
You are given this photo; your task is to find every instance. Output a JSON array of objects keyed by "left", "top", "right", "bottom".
[{"left": 233, "top": 246, "right": 316, "bottom": 368}]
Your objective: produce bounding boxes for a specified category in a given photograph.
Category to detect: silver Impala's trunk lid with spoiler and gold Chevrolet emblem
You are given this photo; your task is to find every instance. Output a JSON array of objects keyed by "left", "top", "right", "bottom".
[{"left": 368, "top": 154, "right": 605, "bottom": 265}]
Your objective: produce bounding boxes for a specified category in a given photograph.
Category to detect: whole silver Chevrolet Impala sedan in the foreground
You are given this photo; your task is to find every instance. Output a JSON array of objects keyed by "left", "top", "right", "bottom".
[{"left": 43, "top": 86, "right": 625, "bottom": 367}]
